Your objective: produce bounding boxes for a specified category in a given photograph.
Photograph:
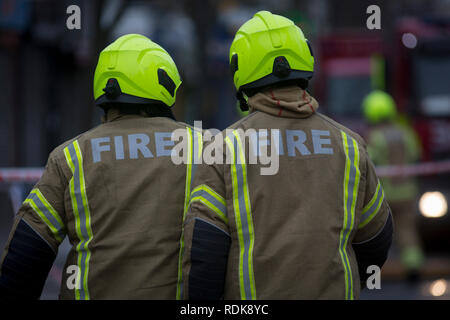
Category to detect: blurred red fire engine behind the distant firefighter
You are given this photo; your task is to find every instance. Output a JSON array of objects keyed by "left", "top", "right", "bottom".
[{"left": 313, "top": 18, "right": 450, "bottom": 253}]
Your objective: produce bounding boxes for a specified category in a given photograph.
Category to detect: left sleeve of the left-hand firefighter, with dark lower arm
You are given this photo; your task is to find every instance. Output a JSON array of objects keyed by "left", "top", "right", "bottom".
[{"left": 0, "top": 151, "right": 65, "bottom": 299}]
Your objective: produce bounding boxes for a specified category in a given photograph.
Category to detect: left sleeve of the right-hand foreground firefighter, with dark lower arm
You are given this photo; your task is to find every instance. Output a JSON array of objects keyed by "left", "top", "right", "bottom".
[{"left": 182, "top": 137, "right": 231, "bottom": 300}]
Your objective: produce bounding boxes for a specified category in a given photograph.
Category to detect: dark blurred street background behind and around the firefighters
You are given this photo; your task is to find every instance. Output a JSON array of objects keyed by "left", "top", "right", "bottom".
[{"left": 0, "top": 0, "right": 450, "bottom": 299}]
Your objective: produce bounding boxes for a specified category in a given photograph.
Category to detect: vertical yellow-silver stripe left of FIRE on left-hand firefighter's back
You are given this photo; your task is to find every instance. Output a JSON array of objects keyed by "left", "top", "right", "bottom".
[{"left": 64, "top": 140, "right": 93, "bottom": 300}]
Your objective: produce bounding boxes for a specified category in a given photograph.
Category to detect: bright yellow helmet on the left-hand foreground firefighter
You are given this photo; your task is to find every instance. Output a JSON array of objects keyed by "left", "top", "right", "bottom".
[{"left": 94, "top": 34, "right": 181, "bottom": 107}]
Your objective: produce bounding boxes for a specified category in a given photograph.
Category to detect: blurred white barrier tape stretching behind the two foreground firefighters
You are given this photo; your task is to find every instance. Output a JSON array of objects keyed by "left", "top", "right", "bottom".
[{"left": 0, "top": 160, "right": 450, "bottom": 183}]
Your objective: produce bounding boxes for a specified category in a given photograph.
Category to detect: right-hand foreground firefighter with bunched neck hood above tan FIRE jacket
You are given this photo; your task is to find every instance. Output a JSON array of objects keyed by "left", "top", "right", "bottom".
[{"left": 182, "top": 11, "right": 393, "bottom": 299}]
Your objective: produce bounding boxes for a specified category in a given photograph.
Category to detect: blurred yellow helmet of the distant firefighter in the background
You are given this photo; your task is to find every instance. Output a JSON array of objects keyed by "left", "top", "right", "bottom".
[{"left": 362, "top": 90, "right": 397, "bottom": 124}]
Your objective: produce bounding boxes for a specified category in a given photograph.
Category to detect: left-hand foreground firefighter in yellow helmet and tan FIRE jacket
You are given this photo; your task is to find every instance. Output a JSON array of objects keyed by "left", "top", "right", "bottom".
[{"left": 0, "top": 34, "right": 198, "bottom": 300}]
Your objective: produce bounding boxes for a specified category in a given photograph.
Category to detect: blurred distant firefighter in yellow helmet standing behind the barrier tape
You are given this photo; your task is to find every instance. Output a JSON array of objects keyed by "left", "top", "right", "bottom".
[{"left": 363, "top": 90, "right": 424, "bottom": 280}]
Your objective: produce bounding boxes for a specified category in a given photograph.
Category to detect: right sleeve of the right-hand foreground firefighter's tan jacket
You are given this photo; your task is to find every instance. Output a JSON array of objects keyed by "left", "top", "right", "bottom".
[{"left": 352, "top": 148, "right": 393, "bottom": 281}]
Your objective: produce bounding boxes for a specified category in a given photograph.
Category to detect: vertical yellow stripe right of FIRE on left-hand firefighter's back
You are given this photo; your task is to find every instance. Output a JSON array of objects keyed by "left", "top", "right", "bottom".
[{"left": 176, "top": 127, "right": 194, "bottom": 300}]
